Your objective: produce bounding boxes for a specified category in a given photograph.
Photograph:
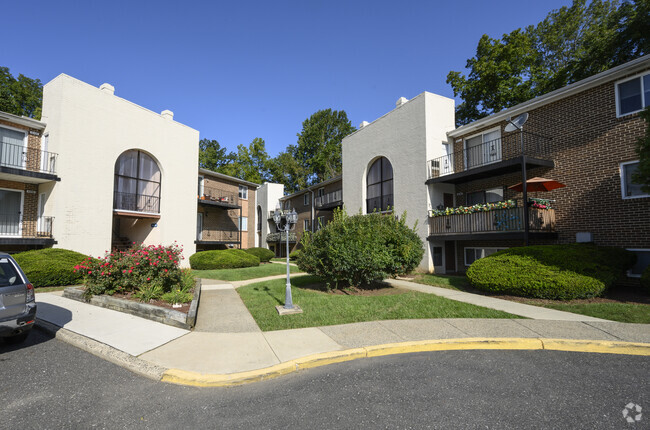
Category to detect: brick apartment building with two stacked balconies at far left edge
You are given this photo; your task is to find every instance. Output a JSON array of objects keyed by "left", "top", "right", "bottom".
[{"left": 0, "top": 112, "right": 60, "bottom": 252}]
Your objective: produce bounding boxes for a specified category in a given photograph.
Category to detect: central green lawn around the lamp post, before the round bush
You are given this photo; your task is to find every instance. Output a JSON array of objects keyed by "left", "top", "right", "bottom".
[{"left": 237, "top": 275, "right": 519, "bottom": 331}]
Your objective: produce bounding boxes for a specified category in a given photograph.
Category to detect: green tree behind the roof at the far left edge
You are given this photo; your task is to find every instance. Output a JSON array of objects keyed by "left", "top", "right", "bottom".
[{"left": 0, "top": 67, "right": 43, "bottom": 120}]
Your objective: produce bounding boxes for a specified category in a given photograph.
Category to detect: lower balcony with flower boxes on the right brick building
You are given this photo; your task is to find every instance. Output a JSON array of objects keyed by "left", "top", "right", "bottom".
[{"left": 429, "top": 207, "right": 556, "bottom": 240}]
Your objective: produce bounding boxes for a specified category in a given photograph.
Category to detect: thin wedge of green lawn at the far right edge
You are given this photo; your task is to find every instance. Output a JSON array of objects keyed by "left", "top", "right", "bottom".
[{"left": 537, "top": 303, "right": 650, "bottom": 324}]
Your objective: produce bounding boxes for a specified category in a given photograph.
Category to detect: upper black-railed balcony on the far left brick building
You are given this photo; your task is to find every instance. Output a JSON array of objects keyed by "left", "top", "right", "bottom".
[{"left": 0, "top": 143, "right": 60, "bottom": 184}]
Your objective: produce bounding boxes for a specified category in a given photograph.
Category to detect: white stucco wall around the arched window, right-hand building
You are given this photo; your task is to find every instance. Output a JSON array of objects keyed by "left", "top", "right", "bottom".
[{"left": 343, "top": 92, "right": 454, "bottom": 271}]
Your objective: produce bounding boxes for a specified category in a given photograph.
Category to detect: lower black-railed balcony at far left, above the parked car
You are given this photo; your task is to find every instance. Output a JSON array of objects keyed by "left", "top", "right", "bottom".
[{"left": 0, "top": 213, "right": 56, "bottom": 246}]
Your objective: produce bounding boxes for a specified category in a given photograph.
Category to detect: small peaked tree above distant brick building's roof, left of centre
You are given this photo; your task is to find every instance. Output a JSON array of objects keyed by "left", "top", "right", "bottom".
[{"left": 221, "top": 137, "right": 271, "bottom": 184}]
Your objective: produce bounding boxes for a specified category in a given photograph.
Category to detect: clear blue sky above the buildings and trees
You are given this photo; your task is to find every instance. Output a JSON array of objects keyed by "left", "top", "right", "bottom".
[{"left": 0, "top": 0, "right": 570, "bottom": 155}]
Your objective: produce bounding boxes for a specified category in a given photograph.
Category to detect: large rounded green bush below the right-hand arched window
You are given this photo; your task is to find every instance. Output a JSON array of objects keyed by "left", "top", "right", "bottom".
[{"left": 297, "top": 210, "right": 424, "bottom": 288}]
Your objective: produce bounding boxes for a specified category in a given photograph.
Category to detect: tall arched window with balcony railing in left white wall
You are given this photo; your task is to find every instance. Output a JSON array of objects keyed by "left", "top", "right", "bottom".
[{"left": 113, "top": 149, "right": 160, "bottom": 214}]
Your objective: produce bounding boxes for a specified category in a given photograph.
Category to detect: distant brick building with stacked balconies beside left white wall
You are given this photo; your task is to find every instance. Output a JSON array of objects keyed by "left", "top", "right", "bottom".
[{"left": 196, "top": 169, "right": 259, "bottom": 251}]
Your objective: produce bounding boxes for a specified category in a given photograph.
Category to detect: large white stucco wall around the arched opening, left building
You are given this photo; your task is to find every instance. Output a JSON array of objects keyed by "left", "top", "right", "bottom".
[{"left": 43, "top": 74, "right": 199, "bottom": 266}]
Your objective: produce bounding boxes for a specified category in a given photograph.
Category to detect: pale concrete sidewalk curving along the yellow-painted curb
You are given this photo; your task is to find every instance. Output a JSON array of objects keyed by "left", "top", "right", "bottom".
[{"left": 36, "top": 279, "right": 650, "bottom": 385}]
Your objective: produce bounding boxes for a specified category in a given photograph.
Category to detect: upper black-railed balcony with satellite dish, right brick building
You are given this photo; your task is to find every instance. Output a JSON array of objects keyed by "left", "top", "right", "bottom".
[{"left": 426, "top": 132, "right": 555, "bottom": 185}]
